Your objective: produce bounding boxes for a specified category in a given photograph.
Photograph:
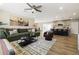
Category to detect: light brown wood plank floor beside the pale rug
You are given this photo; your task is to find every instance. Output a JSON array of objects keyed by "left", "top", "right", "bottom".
[{"left": 48, "top": 35, "right": 78, "bottom": 55}]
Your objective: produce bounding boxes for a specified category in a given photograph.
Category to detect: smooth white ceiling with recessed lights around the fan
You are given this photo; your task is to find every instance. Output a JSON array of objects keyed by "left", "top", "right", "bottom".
[{"left": 0, "top": 3, "right": 79, "bottom": 20}]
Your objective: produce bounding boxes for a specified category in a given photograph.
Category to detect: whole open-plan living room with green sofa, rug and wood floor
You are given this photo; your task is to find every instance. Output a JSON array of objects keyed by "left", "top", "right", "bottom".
[{"left": 0, "top": 3, "right": 79, "bottom": 55}]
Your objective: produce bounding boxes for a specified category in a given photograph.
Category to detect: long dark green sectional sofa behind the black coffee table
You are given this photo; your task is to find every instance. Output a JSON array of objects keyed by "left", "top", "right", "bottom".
[{"left": 0, "top": 29, "right": 40, "bottom": 42}]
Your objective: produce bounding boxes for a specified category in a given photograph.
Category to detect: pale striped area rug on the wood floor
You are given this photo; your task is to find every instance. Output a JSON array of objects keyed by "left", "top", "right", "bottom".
[{"left": 23, "top": 38, "right": 56, "bottom": 55}]
